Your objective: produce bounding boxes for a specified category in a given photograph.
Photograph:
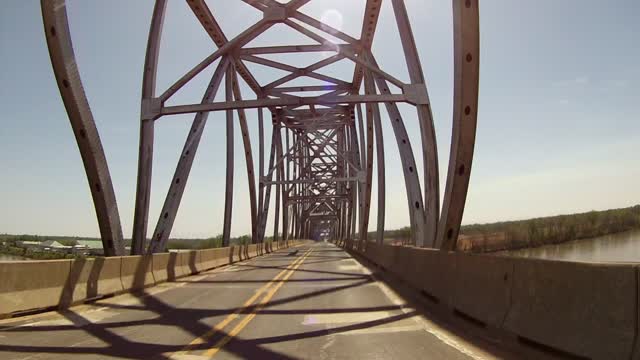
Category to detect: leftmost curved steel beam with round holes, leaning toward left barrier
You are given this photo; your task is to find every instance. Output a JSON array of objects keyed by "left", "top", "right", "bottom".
[{"left": 41, "top": 0, "right": 125, "bottom": 256}]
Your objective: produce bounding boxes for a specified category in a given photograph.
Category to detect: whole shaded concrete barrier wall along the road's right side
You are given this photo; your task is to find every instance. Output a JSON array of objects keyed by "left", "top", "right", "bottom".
[{"left": 353, "top": 243, "right": 640, "bottom": 359}]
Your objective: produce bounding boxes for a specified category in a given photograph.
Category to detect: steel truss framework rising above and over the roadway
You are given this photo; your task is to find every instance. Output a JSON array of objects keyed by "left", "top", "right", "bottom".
[{"left": 42, "top": 0, "right": 479, "bottom": 255}]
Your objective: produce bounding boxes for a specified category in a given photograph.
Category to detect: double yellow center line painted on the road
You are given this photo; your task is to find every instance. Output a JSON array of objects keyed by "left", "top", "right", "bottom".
[{"left": 174, "top": 249, "right": 312, "bottom": 357}]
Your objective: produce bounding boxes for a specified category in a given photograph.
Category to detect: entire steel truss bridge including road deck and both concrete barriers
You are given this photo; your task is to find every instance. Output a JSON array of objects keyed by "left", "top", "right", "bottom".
[{"left": 0, "top": 0, "right": 640, "bottom": 360}]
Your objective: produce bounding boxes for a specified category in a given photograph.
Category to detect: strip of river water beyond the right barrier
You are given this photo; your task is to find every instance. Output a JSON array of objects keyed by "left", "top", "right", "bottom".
[{"left": 506, "top": 230, "right": 640, "bottom": 262}]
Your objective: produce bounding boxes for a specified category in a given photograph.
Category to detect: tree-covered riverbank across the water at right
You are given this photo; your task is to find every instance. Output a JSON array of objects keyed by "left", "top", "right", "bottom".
[{"left": 458, "top": 205, "right": 640, "bottom": 253}]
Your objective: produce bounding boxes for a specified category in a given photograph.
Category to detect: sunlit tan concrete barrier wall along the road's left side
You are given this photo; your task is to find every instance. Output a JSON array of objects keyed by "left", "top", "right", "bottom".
[{"left": 0, "top": 242, "right": 299, "bottom": 317}]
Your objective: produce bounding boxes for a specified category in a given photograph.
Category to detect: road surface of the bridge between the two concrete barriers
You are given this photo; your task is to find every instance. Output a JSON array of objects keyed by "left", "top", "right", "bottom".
[{"left": 0, "top": 243, "right": 504, "bottom": 359}]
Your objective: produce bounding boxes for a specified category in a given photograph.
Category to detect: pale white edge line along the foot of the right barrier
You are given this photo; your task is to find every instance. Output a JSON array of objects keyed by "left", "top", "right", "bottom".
[{"left": 348, "top": 249, "right": 487, "bottom": 360}]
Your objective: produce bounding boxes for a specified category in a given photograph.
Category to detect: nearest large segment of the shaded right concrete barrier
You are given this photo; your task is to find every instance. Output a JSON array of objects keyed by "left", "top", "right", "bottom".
[{"left": 505, "top": 260, "right": 638, "bottom": 359}]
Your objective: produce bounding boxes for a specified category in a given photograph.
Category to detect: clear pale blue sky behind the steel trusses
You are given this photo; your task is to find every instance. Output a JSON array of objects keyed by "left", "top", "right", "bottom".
[{"left": 0, "top": 0, "right": 640, "bottom": 237}]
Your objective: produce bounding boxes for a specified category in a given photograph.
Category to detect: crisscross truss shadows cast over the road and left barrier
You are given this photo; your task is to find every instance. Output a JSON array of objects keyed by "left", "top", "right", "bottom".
[{"left": 0, "top": 243, "right": 510, "bottom": 359}]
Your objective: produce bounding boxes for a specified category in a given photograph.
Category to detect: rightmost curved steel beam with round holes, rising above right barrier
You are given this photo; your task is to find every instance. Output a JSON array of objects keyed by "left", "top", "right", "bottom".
[{"left": 436, "top": 0, "right": 480, "bottom": 250}]
